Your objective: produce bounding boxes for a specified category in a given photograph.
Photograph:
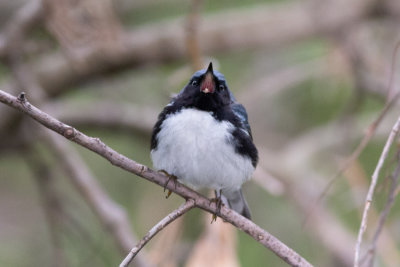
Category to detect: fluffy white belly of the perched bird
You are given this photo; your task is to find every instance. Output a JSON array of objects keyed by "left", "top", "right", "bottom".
[{"left": 151, "top": 109, "right": 254, "bottom": 191}]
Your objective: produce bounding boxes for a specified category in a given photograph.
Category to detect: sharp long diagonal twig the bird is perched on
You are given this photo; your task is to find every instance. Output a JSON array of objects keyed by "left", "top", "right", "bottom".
[{"left": 0, "top": 90, "right": 312, "bottom": 266}]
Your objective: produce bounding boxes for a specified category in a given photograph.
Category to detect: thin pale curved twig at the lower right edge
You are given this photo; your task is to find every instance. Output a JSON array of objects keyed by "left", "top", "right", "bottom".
[{"left": 354, "top": 117, "right": 400, "bottom": 267}]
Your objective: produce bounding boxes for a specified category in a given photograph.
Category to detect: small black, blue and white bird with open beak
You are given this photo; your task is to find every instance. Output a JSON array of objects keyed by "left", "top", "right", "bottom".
[{"left": 151, "top": 63, "right": 258, "bottom": 219}]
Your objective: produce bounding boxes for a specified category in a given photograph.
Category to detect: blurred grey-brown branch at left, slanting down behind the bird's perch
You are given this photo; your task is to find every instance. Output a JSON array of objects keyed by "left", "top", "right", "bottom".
[{"left": 0, "top": 4, "right": 148, "bottom": 266}]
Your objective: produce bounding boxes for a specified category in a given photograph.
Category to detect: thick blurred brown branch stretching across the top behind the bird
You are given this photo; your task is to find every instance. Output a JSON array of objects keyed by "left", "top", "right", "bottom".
[{"left": 10, "top": 0, "right": 371, "bottom": 95}]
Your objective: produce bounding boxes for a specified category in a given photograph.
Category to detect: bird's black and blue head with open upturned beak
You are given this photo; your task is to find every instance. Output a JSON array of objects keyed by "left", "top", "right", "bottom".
[{"left": 177, "top": 63, "right": 233, "bottom": 111}]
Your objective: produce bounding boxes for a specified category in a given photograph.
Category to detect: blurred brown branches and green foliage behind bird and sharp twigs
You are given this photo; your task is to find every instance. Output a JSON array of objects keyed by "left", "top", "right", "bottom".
[{"left": 0, "top": 0, "right": 400, "bottom": 267}]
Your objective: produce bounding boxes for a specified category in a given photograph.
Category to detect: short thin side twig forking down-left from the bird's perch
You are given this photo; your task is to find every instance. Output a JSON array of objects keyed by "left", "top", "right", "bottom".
[{"left": 119, "top": 199, "right": 195, "bottom": 267}]
